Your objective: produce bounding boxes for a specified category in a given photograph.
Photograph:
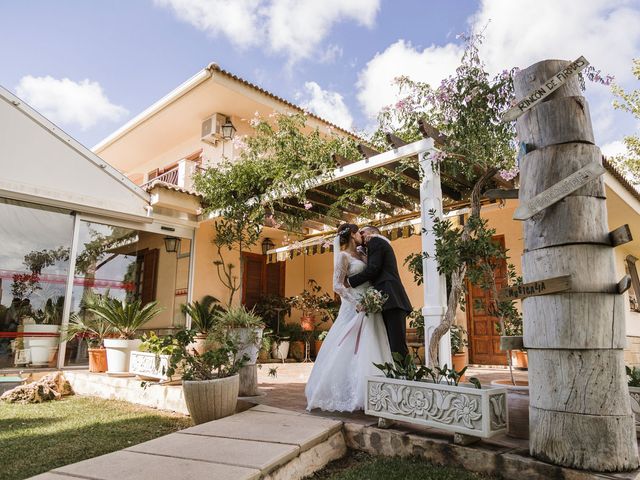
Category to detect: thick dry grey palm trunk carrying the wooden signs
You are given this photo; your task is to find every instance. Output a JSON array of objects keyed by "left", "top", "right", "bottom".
[{"left": 515, "top": 60, "right": 638, "bottom": 471}]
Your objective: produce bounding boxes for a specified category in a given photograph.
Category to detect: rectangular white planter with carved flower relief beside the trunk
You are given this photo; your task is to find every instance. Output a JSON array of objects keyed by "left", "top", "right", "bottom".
[{"left": 364, "top": 375, "right": 507, "bottom": 438}]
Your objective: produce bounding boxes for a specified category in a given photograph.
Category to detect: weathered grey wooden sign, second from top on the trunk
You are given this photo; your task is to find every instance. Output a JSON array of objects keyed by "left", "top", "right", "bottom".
[{"left": 513, "top": 163, "right": 605, "bottom": 220}]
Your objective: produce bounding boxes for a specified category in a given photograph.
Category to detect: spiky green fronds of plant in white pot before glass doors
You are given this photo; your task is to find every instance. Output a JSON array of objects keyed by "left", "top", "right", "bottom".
[{"left": 87, "top": 297, "right": 163, "bottom": 339}]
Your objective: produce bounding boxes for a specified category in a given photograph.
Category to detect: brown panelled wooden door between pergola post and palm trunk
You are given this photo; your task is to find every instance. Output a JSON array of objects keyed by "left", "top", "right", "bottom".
[{"left": 466, "top": 235, "right": 507, "bottom": 365}]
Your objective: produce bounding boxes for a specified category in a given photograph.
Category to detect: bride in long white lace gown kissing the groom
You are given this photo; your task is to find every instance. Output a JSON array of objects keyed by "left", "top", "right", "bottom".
[{"left": 305, "top": 223, "right": 392, "bottom": 412}]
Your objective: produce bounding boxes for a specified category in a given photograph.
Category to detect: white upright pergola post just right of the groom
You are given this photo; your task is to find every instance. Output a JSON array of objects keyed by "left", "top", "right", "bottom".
[{"left": 418, "top": 151, "right": 452, "bottom": 367}]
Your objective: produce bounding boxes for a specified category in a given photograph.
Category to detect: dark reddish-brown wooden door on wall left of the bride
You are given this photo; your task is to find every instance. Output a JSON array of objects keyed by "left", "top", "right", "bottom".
[{"left": 242, "top": 252, "right": 285, "bottom": 308}]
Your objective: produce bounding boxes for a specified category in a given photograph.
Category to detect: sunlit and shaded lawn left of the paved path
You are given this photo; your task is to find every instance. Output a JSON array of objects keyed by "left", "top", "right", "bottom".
[{"left": 0, "top": 397, "right": 192, "bottom": 480}]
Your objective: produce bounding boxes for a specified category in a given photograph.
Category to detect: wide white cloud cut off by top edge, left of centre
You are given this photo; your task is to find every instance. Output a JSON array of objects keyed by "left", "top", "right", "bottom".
[{"left": 154, "top": 0, "right": 380, "bottom": 64}]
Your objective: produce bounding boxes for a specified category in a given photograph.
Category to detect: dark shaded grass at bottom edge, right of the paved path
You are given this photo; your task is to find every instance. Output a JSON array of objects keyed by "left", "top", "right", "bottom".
[{"left": 306, "top": 451, "right": 493, "bottom": 480}]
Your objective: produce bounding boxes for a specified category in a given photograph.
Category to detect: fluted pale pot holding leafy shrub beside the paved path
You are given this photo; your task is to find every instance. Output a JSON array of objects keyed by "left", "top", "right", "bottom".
[{"left": 182, "top": 375, "right": 240, "bottom": 425}]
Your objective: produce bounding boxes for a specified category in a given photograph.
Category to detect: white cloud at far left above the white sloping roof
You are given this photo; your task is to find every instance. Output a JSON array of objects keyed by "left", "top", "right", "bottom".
[{"left": 16, "top": 75, "right": 129, "bottom": 130}]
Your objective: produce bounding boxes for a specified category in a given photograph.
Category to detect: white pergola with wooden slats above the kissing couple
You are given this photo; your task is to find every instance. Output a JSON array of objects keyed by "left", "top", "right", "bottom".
[{"left": 267, "top": 129, "right": 513, "bottom": 365}]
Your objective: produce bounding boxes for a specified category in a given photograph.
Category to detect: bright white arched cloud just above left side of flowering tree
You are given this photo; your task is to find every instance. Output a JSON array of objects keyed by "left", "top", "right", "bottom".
[{"left": 356, "top": 40, "right": 462, "bottom": 118}]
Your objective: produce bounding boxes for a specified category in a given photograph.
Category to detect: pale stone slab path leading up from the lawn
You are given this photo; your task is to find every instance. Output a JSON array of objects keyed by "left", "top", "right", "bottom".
[{"left": 32, "top": 405, "right": 346, "bottom": 480}]
